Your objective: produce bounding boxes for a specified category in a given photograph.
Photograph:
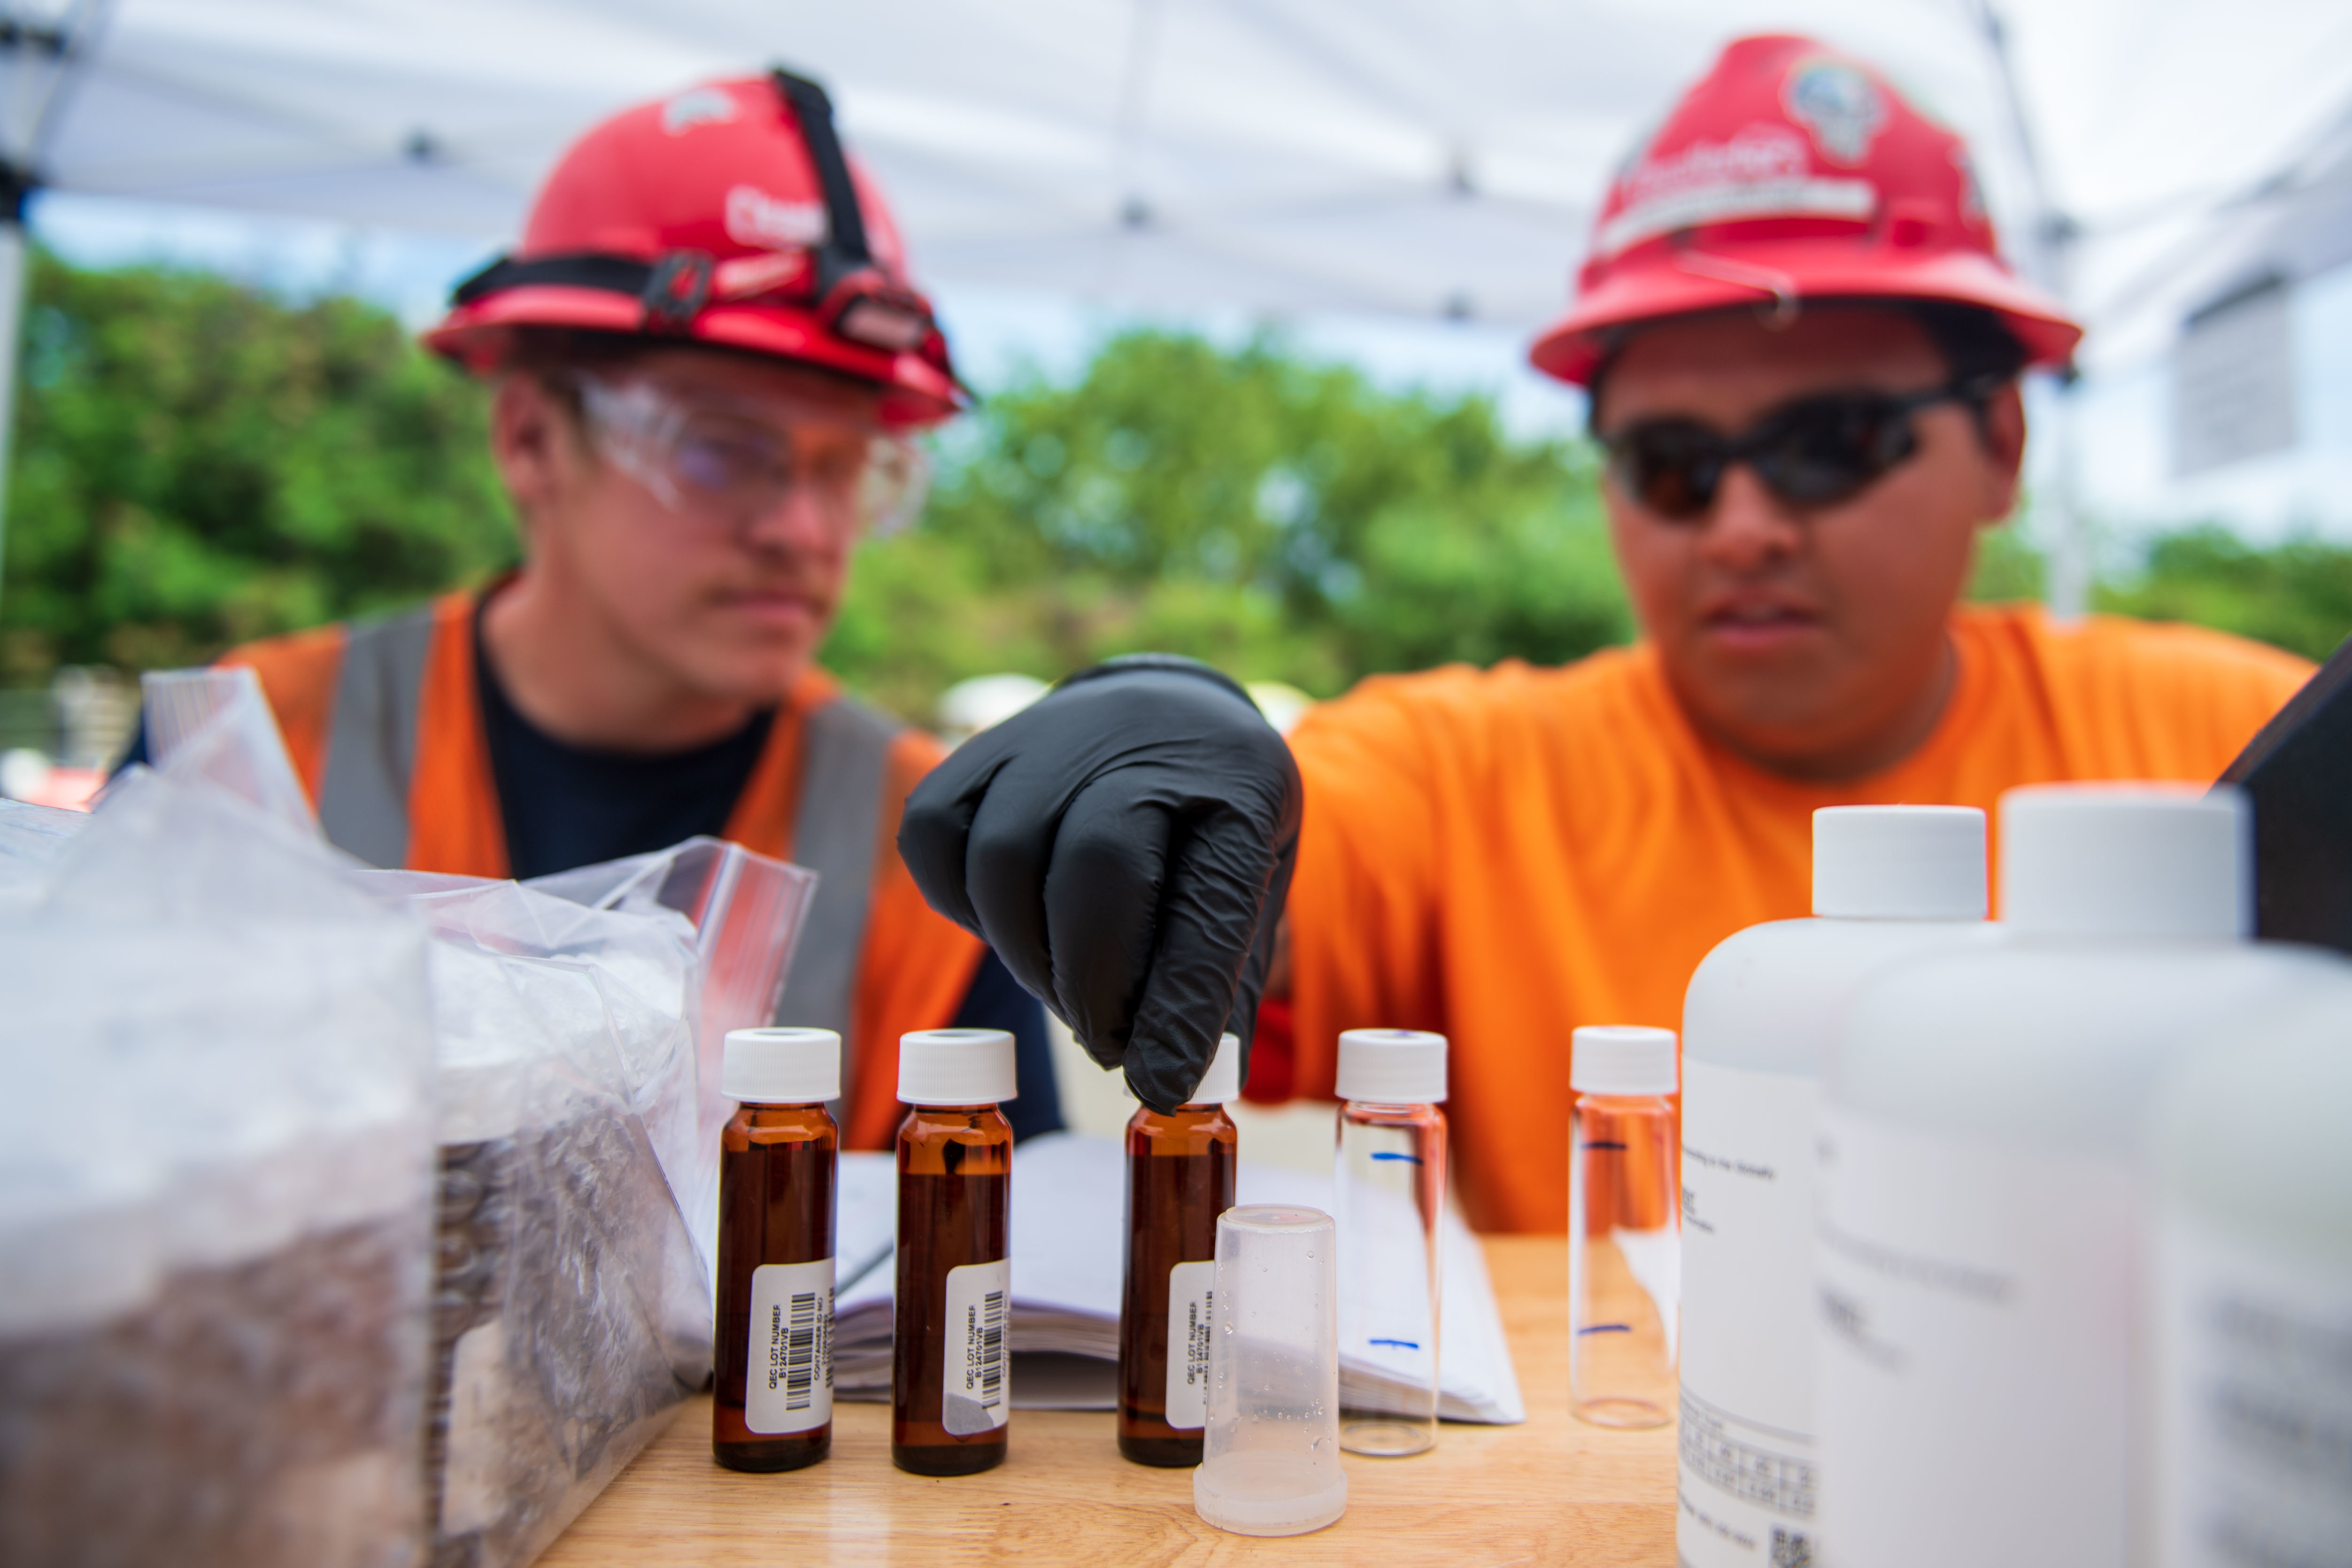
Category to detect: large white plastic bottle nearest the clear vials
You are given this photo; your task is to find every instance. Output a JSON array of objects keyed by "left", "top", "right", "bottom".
[{"left": 1674, "top": 806, "right": 1997, "bottom": 1568}]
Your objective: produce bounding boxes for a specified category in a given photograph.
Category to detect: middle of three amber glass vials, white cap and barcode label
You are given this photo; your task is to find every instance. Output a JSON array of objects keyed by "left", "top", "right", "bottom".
[{"left": 889, "top": 1030, "right": 1014, "bottom": 1476}]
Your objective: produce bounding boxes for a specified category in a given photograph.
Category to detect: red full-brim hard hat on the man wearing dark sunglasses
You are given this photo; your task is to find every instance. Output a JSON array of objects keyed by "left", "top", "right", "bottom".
[{"left": 1527, "top": 38, "right": 2082, "bottom": 386}]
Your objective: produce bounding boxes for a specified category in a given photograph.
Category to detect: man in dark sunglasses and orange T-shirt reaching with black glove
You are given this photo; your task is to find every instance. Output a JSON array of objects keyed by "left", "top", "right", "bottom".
[{"left": 898, "top": 38, "right": 2310, "bottom": 1194}]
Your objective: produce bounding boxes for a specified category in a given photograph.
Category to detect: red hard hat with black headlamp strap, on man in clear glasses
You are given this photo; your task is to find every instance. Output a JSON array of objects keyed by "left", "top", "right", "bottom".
[{"left": 424, "top": 70, "right": 964, "bottom": 428}]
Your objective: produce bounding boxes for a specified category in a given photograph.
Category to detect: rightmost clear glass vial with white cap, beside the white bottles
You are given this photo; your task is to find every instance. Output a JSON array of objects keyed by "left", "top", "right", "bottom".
[{"left": 1569, "top": 1025, "right": 1681, "bottom": 1427}]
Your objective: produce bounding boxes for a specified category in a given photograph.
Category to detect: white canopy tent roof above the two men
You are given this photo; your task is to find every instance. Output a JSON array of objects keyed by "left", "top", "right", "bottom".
[{"left": 0, "top": 0, "right": 2352, "bottom": 606}]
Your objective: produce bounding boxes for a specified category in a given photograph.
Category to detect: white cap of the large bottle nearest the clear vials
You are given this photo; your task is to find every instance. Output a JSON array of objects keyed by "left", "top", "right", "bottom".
[{"left": 1813, "top": 806, "right": 1988, "bottom": 919}]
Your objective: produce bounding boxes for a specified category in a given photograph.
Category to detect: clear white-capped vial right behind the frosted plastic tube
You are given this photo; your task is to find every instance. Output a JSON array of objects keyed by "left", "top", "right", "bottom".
[{"left": 1331, "top": 1030, "right": 1447, "bottom": 1458}]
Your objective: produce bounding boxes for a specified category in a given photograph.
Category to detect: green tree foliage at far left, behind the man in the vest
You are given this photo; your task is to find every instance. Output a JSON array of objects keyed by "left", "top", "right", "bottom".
[{"left": 0, "top": 252, "right": 515, "bottom": 682}]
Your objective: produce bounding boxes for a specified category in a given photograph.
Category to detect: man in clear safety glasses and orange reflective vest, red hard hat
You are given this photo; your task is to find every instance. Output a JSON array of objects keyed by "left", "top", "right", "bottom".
[{"left": 211, "top": 73, "right": 1061, "bottom": 1147}]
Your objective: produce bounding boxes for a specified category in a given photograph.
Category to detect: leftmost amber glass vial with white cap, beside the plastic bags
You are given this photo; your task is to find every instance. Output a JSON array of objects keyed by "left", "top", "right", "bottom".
[{"left": 710, "top": 1030, "right": 842, "bottom": 1472}]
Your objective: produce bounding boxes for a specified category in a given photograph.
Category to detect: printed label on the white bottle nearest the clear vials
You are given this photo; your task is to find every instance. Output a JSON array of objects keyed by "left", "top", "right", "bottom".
[{"left": 1674, "top": 1058, "right": 1820, "bottom": 1568}]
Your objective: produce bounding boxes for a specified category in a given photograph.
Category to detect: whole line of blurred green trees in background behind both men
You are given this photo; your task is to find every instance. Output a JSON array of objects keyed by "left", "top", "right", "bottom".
[{"left": 0, "top": 254, "right": 2352, "bottom": 719}]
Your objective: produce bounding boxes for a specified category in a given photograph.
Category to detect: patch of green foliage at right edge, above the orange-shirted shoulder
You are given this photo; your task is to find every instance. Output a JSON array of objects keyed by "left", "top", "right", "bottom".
[{"left": 2098, "top": 522, "right": 2352, "bottom": 658}]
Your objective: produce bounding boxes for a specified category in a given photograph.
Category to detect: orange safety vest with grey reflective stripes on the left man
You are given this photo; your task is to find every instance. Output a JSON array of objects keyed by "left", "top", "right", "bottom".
[{"left": 221, "top": 593, "right": 981, "bottom": 1150}]
